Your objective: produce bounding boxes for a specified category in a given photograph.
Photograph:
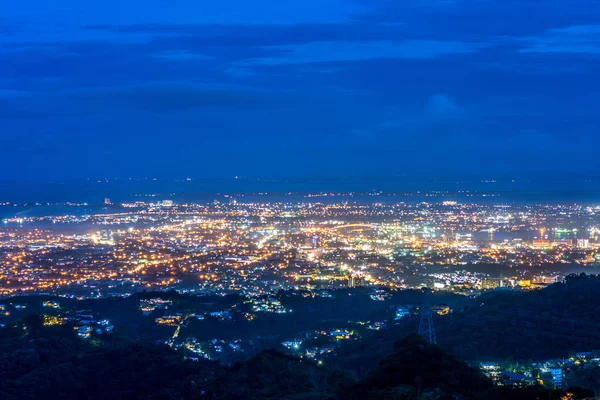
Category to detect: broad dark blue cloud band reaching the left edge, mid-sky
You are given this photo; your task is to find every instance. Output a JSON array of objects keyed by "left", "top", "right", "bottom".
[{"left": 0, "top": 81, "right": 302, "bottom": 122}]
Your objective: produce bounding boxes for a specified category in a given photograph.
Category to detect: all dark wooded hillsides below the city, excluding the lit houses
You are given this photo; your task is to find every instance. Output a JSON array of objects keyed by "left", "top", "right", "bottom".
[{"left": 0, "top": 275, "right": 600, "bottom": 400}]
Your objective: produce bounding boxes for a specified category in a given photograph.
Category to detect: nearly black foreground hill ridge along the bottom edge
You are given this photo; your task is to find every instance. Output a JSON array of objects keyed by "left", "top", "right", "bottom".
[{"left": 0, "top": 315, "right": 593, "bottom": 400}]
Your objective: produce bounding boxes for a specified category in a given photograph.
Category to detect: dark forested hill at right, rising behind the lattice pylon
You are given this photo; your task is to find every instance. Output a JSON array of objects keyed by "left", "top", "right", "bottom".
[{"left": 328, "top": 275, "right": 600, "bottom": 375}]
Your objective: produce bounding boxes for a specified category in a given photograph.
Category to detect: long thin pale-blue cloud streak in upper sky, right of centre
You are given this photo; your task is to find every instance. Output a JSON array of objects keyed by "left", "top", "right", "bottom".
[{"left": 242, "top": 40, "right": 484, "bottom": 66}]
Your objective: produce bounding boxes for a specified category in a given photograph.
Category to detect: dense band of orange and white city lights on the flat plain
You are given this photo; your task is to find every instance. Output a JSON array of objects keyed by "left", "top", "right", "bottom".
[{"left": 0, "top": 195, "right": 600, "bottom": 298}]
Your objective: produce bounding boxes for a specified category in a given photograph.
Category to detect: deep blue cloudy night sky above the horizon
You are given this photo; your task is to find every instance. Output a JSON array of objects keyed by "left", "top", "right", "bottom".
[{"left": 0, "top": 0, "right": 600, "bottom": 180}]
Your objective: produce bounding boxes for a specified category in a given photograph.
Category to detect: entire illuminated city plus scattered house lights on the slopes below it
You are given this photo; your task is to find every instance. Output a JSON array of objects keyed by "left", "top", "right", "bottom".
[{"left": 0, "top": 192, "right": 600, "bottom": 396}]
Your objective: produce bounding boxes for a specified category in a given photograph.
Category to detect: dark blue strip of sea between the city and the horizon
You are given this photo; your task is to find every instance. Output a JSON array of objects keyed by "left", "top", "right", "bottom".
[{"left": 0, "top": 174, "right": 600, "bottom": 218}]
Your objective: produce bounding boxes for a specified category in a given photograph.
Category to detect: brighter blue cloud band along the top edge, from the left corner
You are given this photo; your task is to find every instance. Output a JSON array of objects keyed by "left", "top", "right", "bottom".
[{"left": 0, "top": 0, "right": 365, "bottom": 38}]
